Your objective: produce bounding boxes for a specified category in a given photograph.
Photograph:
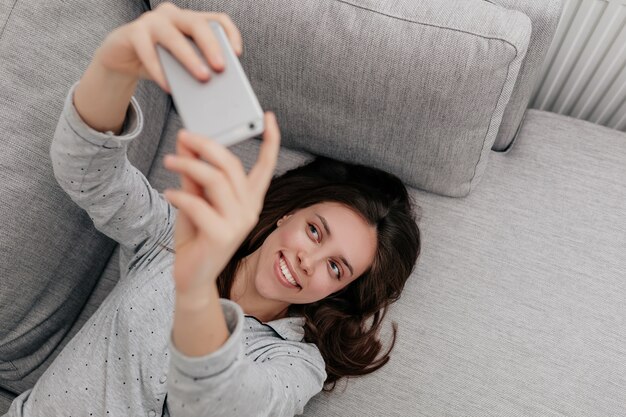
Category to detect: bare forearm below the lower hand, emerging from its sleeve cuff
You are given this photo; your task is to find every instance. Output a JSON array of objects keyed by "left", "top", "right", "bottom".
[{"left": 172, "top": 282, "right": 230, "bottom": 356}]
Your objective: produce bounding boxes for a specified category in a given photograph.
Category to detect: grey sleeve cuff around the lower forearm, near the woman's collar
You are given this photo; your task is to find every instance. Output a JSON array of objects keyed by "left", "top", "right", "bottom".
[{"left": 168, "top": 298, "right": 244, "bottom": 379}]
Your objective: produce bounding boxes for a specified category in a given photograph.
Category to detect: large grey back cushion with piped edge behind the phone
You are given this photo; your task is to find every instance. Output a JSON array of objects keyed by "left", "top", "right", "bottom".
[{"left": 151, "top": 0, "right": 531, "bottom": 196}]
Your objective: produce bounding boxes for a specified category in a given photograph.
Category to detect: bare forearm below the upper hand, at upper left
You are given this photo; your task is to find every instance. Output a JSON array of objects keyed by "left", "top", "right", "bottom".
[{"left": 74, "top": 51, "right": 137, "bottom": 134}]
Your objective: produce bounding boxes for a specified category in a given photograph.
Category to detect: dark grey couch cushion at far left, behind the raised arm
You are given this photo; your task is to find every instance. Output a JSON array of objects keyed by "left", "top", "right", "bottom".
[{"left": 0, "top": 0, "right": 169, "bottom": 387}]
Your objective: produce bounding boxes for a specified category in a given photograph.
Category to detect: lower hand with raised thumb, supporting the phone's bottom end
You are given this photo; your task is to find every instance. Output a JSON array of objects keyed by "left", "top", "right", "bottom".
[{"left": 163, "top": 112, "right": 280, "bottom": 294}]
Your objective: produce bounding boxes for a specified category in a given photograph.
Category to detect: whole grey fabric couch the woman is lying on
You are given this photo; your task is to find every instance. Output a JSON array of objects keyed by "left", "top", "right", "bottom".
[{"left": 0, "top": 0, "right": 626, "bottom": 417}]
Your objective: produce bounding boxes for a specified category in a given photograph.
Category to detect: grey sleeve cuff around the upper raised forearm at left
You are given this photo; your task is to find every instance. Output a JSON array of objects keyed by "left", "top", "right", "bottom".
[{"left": 64, "top": 81, "right": 144, "bottom": 148}]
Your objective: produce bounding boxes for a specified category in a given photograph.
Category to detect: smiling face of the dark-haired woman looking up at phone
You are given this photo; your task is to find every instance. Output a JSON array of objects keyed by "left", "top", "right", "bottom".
[{"left": 255, "top": 202, "right": 377, "bottom": 304}]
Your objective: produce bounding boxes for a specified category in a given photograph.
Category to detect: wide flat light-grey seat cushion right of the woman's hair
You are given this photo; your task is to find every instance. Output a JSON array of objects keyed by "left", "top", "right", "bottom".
[{"left": 304, "top": 110, "right": 626, "bottom": 417}]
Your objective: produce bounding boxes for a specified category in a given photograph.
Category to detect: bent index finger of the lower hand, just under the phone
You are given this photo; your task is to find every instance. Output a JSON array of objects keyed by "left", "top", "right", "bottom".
[{"left": 178, "top": 130, "right": 247, "bottom": 201}]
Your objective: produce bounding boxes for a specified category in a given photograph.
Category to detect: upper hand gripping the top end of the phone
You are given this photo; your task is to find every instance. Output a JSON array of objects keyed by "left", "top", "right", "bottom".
[{"left": 92, "top": 3, "right": 243, "bottom": 93}]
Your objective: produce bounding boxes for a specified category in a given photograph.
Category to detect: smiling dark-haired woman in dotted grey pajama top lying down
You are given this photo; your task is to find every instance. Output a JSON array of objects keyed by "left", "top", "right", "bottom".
[{"left": 7, "top": 4, "right": 420, "bottom": 417}]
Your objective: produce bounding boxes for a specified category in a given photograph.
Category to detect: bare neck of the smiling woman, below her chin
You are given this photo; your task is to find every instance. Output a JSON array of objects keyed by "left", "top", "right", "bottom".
[{"left": 230, "top": 250, "right": 289, "bottom": 323}]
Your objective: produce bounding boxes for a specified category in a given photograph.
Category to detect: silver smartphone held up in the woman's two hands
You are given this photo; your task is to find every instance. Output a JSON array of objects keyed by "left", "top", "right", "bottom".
[{"left": 157, "top": 21, "right": 265, "bottom": 146}]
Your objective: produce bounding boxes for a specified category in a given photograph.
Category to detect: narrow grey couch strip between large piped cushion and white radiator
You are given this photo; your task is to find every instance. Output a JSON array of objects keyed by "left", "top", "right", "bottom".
[{"left": 488, "top": 0, "right": 565, "bottom": 151}]
